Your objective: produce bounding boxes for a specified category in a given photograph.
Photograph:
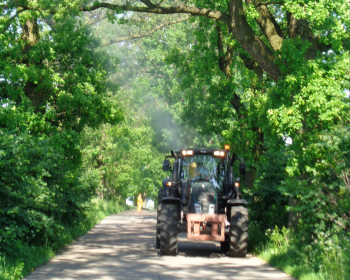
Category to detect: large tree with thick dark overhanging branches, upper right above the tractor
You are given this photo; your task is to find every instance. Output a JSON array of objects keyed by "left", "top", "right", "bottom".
[{"left": 1, "top": 0, "right": 350, "bottom": 247}]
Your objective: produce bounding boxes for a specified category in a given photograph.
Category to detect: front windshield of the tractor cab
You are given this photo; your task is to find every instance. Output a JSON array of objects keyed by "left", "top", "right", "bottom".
[{"left": 181, "top": 155, "right": 225, "bottom": 192}]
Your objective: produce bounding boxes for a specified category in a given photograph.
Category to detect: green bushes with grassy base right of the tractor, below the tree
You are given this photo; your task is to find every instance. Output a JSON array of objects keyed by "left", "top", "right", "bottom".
[{"left": 247, "top": 126, "right": 350, "bottom": 280}]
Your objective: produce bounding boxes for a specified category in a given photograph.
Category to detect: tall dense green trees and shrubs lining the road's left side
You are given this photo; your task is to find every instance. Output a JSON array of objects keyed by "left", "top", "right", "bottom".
[{"left": 0, "top": 1, "right": 122, "bottom": 260}]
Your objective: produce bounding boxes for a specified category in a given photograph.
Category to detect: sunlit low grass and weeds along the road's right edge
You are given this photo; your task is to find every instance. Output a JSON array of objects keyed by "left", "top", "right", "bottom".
[{"left": 250, "top": 224, "right": 350, "bottom": 280}]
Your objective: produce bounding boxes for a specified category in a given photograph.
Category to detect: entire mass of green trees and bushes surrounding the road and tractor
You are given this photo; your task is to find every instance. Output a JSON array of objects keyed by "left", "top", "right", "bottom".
[{"left": 0, "top": 0, "right": 350, "bottom": 279}]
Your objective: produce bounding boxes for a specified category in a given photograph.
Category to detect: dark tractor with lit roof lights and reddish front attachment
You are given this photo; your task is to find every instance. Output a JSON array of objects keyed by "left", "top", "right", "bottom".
[{"left": 156, "top": 148, "right": 248, "bottom": 258}]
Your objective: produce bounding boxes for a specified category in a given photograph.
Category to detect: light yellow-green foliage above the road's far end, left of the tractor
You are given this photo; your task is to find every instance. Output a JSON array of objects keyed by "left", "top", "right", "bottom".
[{"left": 82, "top": 112, "right": 164, "bottom": 202}]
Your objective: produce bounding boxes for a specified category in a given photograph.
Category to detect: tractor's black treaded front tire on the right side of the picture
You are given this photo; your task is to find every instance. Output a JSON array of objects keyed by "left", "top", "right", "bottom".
[{"left": 229, "top": 206, "right": 248, "bottom": 258}]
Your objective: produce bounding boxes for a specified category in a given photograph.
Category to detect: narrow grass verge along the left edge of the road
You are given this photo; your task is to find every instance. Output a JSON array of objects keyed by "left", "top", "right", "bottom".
[{"left": 0, "top": 199, "right": 130, "bottom": 280}]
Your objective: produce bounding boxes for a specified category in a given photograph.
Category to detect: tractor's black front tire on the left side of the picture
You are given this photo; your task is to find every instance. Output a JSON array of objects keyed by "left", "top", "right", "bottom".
[{"left": 159, "top": 203, "right": 178, "bottom": 256}]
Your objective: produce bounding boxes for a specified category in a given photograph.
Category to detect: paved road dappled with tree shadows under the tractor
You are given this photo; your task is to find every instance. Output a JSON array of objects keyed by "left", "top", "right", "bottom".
[{"left": 25, "top": 210, "right": 293, "bottom": 280}]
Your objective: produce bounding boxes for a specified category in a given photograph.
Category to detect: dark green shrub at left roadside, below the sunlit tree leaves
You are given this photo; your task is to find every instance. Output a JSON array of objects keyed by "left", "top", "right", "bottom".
[{"left": 0, "top": 132, "right": 95, "bottom": 254}]
